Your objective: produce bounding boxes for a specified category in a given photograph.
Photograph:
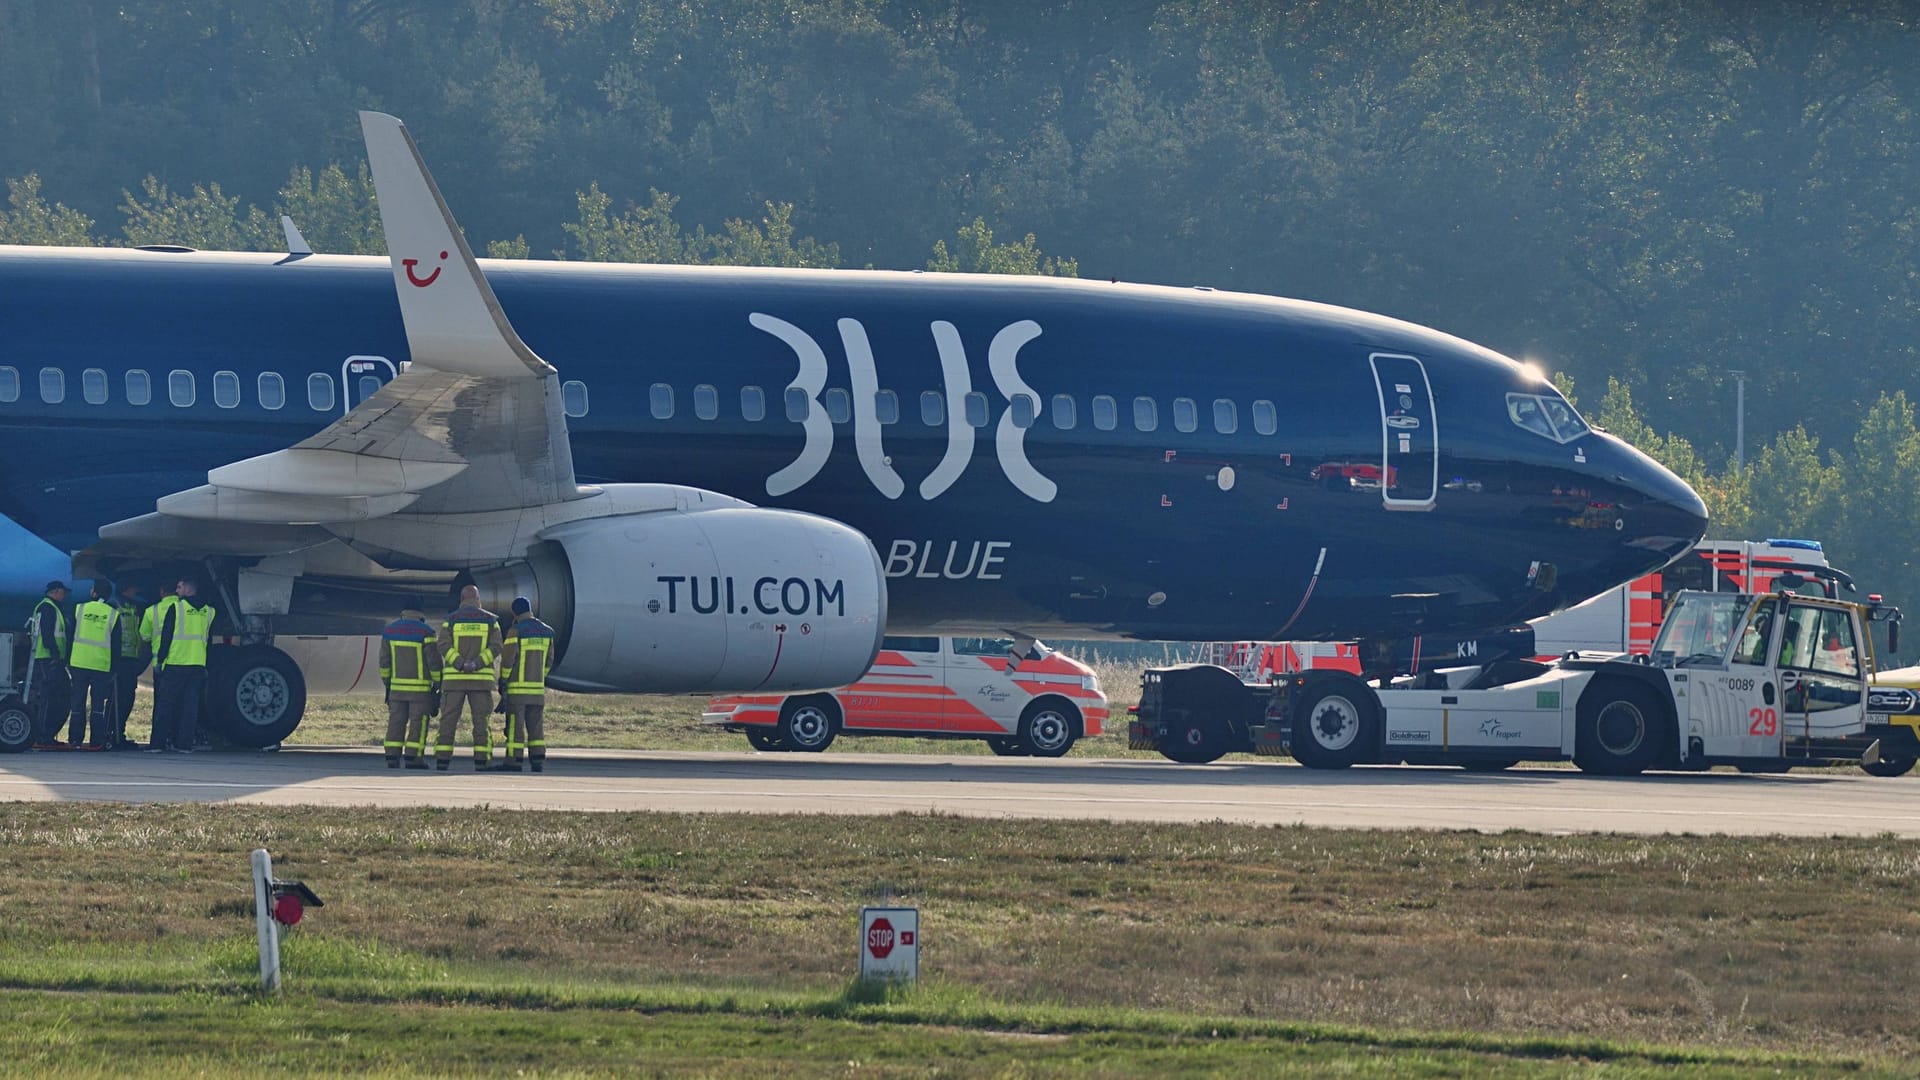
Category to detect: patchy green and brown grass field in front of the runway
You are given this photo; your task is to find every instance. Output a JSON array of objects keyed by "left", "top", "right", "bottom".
[{"left": 0, "top": 805, "right": 1920, "bottom": 1076}]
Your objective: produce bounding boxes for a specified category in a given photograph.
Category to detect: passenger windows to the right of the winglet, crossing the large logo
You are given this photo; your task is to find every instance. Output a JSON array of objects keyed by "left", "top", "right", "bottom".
[{"left": 637, "top": 382, "right": 1279, "bottom": 434}]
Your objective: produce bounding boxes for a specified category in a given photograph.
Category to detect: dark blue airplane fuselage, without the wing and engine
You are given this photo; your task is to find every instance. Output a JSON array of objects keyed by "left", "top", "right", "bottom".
[{"left": 0, "top": 248, "right": 1705, "bottom": 640}]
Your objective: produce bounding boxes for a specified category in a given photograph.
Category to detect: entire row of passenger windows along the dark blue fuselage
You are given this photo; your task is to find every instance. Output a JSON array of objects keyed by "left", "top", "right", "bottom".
[{"left": 0, "top": 367, "right": 1279, "bottom": 434}]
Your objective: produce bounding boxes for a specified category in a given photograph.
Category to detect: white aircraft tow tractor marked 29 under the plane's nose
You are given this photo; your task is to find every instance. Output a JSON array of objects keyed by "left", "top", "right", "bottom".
[{"left": 1129, "top": 575, "right": 1899, "bottom": 774}]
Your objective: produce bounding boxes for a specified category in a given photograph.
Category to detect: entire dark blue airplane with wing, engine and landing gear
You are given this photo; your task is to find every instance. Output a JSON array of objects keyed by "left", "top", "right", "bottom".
[{"left": 0, "top": 113, "right": 1707, "bottom": 746}]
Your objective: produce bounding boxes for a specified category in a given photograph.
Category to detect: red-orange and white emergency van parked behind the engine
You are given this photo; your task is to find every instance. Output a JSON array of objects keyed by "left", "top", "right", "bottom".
[{"left": 701, "top": 636, "right": 1106, "bottom": 757}]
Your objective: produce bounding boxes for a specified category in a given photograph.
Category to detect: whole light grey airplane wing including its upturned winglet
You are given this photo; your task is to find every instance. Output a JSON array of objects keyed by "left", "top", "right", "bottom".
[{"left": 102, "top": 111, "right": 591, "bottom": 553}]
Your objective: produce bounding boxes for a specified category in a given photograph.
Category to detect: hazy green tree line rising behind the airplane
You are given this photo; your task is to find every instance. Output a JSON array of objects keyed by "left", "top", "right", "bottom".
[{"left": 11, "top": 0, "right": 1920, "bottom": 614}]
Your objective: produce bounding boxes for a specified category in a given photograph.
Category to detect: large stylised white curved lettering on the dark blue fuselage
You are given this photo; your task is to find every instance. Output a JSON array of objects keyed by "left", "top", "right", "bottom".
[{"left": 747, "top": 311, "right": 1058, "bottom": 502}]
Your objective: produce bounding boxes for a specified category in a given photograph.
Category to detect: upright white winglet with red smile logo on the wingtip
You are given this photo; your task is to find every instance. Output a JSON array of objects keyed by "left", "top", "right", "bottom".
[{"left": 361, "top": 111, "right": 553, "bottom": 379}]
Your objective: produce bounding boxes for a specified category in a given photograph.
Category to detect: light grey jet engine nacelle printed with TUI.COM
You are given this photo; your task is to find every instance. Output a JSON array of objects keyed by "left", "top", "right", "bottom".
[{"left": 472, "top": 505, "right": 887, "bottom": 694}]
